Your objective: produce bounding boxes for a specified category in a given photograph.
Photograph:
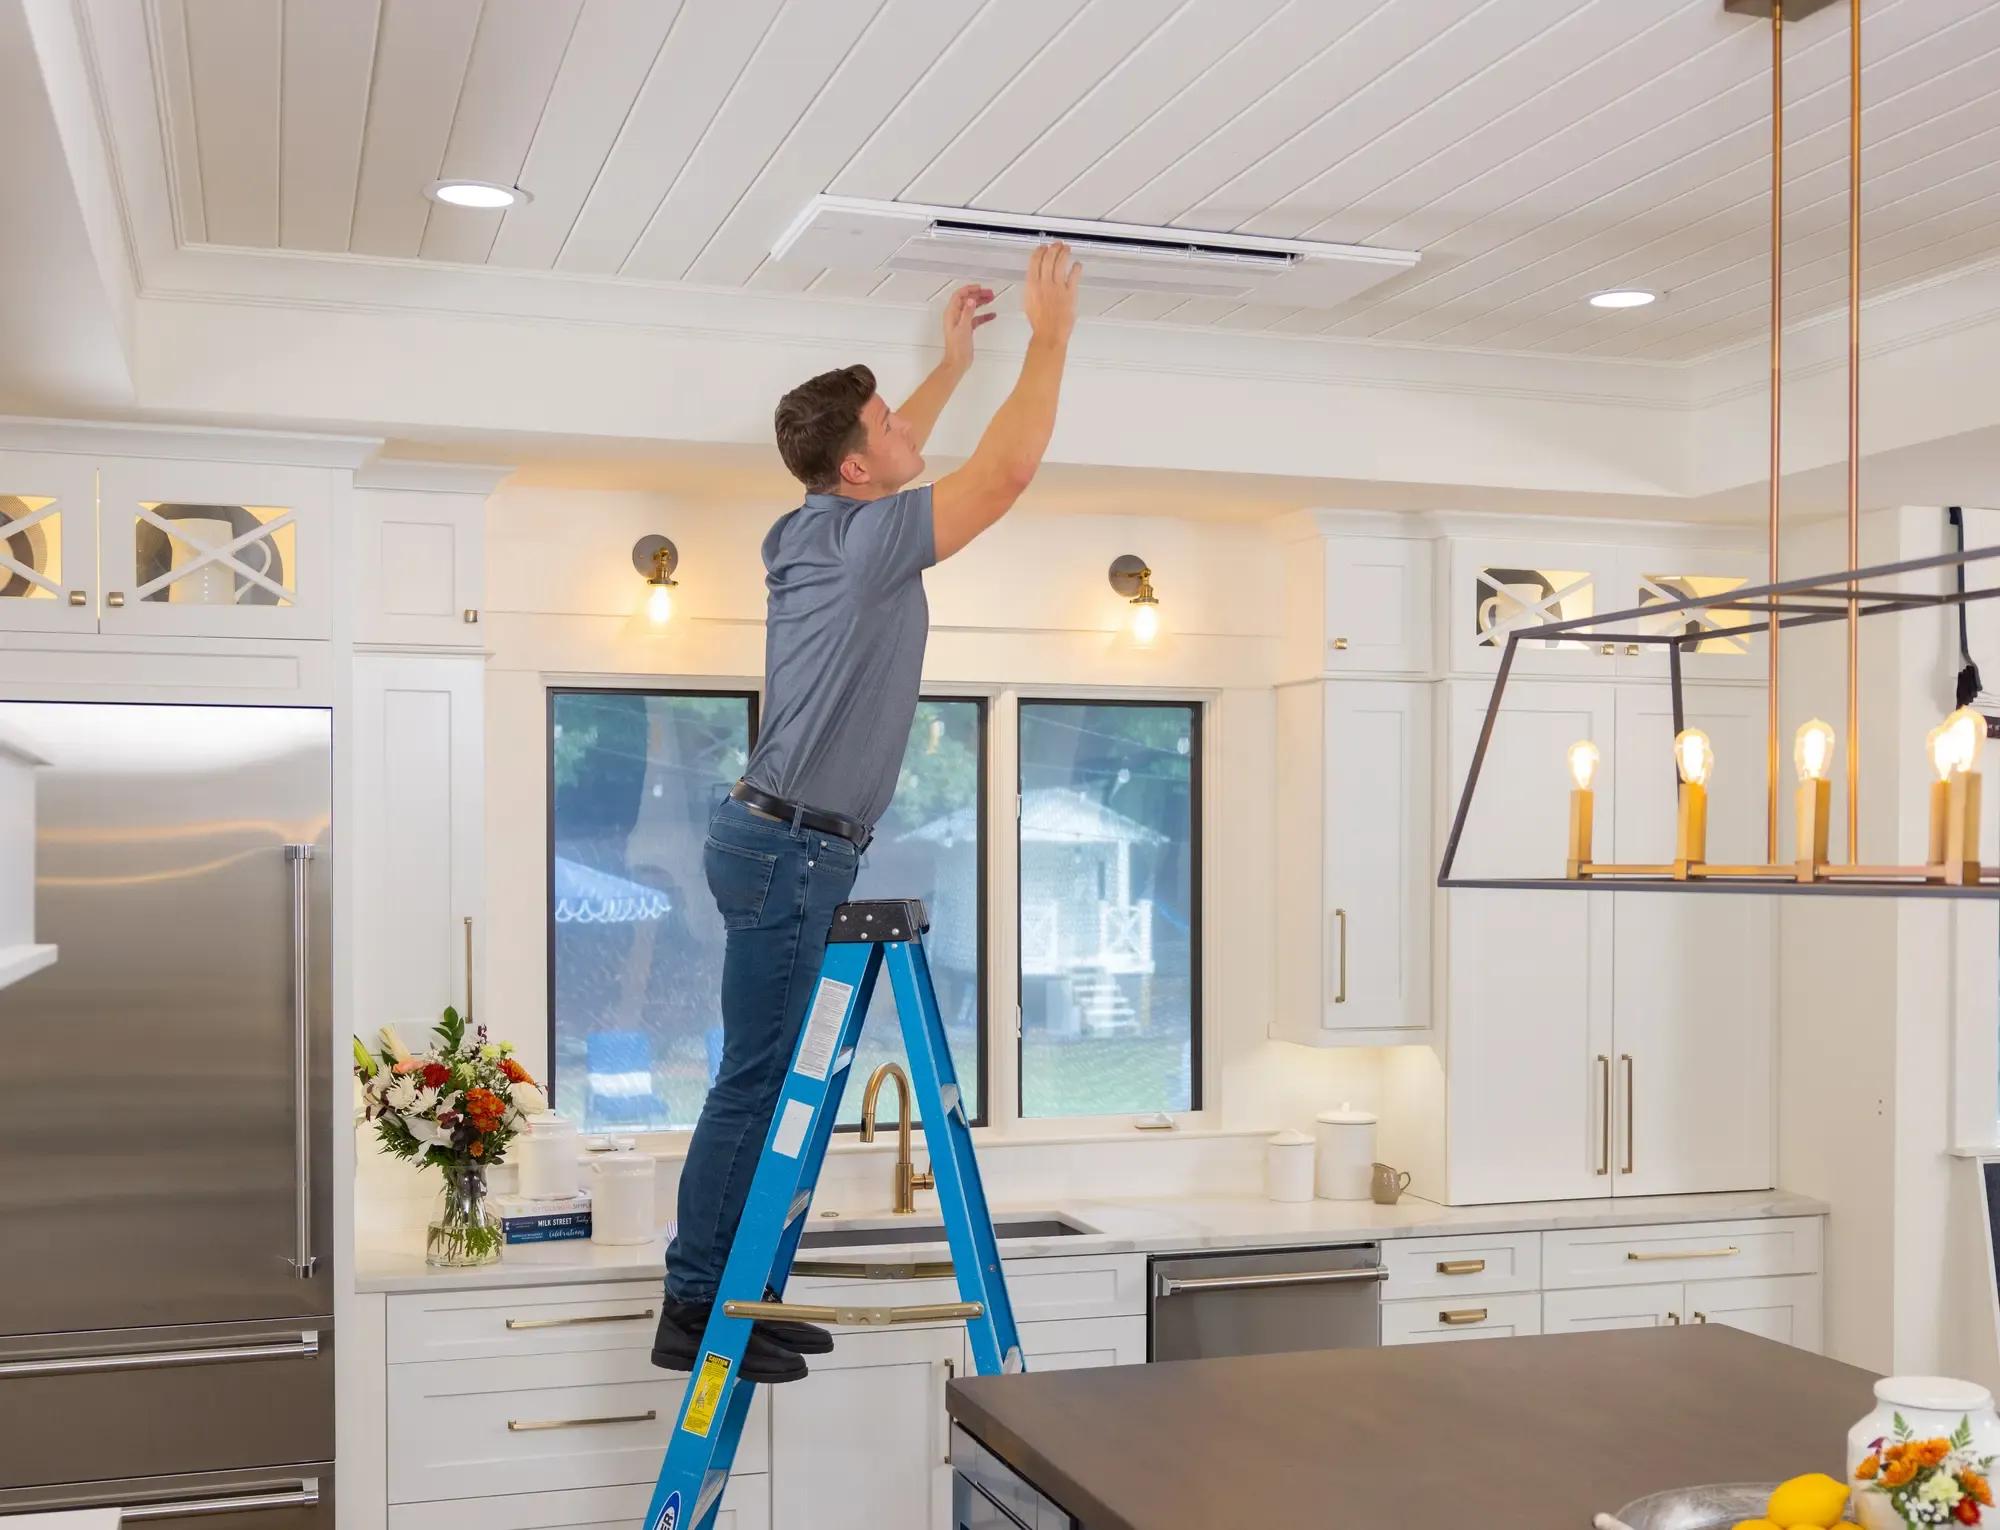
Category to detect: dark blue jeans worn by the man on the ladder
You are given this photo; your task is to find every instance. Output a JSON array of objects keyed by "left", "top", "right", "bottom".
[{"left": 666, "top": 798, "right": 860, "bottom": 1302}]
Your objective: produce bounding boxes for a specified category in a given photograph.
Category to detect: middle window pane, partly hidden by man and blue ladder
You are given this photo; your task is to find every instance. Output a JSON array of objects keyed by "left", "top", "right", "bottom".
[{"left": 840, "top": 696, "right": 986, "bottom": 1126}]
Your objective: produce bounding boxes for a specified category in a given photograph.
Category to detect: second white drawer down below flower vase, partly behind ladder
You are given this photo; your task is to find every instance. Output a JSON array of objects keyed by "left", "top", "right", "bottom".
[{"left": 388, "top": 1348, "right": 770, "bottom": 1504}]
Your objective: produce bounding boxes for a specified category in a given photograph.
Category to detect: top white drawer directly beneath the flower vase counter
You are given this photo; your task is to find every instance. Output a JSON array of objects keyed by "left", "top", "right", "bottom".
[{"left": 388, "top": 1280, "right": 660, "bottom": 1366}]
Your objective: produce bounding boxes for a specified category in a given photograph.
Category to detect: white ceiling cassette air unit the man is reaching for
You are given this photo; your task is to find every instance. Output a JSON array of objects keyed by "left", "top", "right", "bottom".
[{"left": 770, "top": 196, "right": 1418, "bottom": 308}]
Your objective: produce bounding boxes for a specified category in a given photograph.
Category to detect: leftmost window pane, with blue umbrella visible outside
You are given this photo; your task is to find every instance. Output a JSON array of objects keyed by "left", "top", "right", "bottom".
[{"left": 548, "top": 690, "right": 756, "bottom": 1132}]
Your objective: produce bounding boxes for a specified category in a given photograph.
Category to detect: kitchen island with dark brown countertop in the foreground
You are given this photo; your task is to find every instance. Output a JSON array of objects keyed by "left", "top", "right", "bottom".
[{"left": 946, "top": 1324, "right": 1874, "bottom": 1530}]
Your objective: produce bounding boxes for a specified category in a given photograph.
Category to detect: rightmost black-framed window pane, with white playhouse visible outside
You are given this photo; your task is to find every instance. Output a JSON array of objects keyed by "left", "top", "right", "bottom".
[{"left": 1020, "top": 700, "right": 1202, "bottom": 1118}]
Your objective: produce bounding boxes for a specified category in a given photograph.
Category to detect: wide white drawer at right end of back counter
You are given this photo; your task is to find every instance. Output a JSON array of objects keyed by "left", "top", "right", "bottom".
[{"left": 1542, "top": 1216, "right": 1820, "bottom": 1290}]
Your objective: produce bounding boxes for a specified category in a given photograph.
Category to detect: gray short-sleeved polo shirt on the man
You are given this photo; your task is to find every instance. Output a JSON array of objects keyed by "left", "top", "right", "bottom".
[{"left": 744, "top": 484, "right": 938, "bottom": 826}]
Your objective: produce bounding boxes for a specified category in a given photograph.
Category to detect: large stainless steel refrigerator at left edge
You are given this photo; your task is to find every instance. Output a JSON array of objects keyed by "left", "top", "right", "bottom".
[{"left": 0, "top": 702, "right": 334, "bottom": 1530}]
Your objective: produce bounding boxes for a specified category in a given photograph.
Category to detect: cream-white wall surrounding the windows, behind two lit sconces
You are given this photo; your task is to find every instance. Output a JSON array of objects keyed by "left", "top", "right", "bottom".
[{"left": 484, "top": 488, "right": 1378, "bottom": 1152}]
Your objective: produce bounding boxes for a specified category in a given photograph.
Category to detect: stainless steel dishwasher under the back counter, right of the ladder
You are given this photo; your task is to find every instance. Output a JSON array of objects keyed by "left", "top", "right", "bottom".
[{"left": 1148, "top": 1244, "right": 1388, "bottom": 1360}]
